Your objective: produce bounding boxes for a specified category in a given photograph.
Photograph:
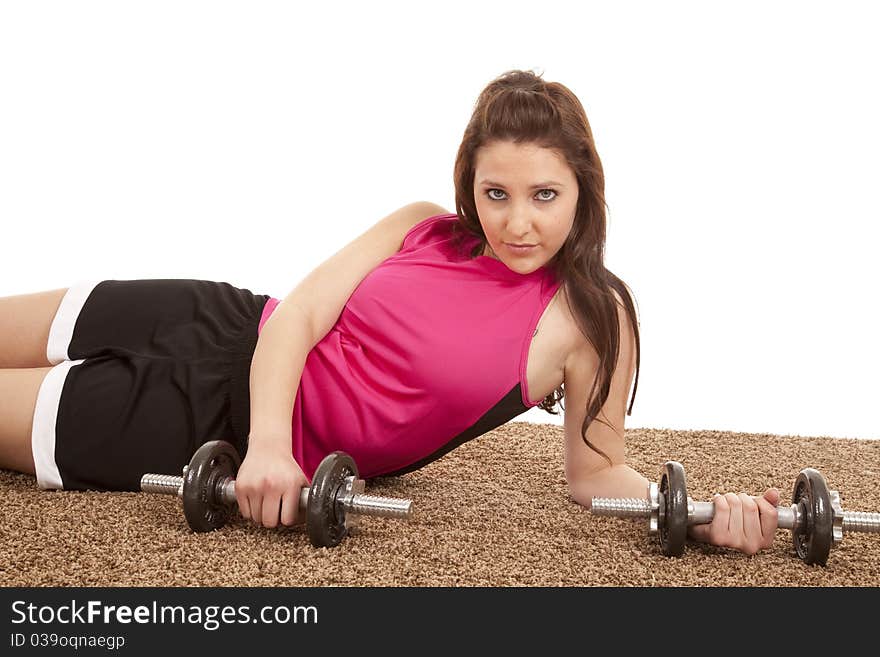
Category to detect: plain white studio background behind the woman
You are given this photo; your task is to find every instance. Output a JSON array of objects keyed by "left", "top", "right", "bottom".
[{"left": 0, "top": 0, "right": 880, "bottom": 438}]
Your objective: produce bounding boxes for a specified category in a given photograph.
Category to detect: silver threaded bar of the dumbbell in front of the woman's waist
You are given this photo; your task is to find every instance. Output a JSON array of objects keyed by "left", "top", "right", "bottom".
[{"left": 141, "top": 474, "right": 412, "bottom": 519}]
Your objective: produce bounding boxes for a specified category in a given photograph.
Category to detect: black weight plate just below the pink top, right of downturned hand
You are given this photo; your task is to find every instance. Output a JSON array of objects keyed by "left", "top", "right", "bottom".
[{"left": 306, "top": 451, "right": 358, "bottom": 547}]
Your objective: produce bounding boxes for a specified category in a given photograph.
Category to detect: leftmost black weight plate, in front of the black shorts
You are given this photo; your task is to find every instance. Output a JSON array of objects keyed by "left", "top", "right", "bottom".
[{"left": 183, "top": 440, "right": 241, "bottom": 532}]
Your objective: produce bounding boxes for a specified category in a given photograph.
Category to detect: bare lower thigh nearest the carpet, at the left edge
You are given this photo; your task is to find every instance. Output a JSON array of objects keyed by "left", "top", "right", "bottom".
[{"left": 0, "top": 367, "right": 52, "bottom": 475}]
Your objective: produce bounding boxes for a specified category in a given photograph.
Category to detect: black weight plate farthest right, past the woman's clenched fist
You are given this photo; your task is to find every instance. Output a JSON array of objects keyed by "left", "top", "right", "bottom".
[{"left": 791, "top": 468, "right": 834, "bottom": 566}]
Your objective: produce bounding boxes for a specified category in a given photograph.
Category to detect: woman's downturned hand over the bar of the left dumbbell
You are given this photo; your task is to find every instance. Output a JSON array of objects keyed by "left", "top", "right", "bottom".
[{"left": 235, "top": 437, "right": 309, "bottom": 527}]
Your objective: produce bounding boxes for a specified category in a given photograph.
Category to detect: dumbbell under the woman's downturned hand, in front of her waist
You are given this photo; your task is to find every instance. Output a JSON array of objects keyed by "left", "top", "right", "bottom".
[{"left": 141, "top": 440, "right": 412, "bottom": 547}]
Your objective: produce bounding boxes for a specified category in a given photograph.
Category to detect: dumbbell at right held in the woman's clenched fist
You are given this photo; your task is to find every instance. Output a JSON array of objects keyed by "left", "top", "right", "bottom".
[{"left": 591, "top": 461, "right": 880, "bottom": 566}]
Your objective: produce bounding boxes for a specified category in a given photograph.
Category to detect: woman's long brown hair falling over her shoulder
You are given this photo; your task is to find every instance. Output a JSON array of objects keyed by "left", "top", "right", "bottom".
[{"left": 454, "top": 70, "right": 640, "bottom": 463}]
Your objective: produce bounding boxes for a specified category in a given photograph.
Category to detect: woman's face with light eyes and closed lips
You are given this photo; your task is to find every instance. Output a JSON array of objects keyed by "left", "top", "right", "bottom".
[{"left": 474, "top": 141, "right": 578, "bottom": 274}]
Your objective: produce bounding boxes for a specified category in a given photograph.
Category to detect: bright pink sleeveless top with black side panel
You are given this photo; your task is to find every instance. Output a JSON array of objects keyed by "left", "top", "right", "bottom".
[{"left": 259, "top": 214, "right": 560, "bottom": 478}]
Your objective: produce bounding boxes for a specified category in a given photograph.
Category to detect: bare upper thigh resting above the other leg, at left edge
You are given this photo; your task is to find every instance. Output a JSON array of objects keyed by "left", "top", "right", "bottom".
[{"left": 0, "top": 288, "right": 67, "bottom": 368}]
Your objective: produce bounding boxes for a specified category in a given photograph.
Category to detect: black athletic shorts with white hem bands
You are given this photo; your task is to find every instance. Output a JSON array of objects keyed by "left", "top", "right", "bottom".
[{"left": 32, "top": 279, "right": 270, "bottom": 491}]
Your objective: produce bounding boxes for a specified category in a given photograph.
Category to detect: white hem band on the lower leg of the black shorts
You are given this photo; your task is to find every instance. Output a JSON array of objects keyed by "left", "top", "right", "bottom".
[{"left": 31, "top": 360, "right": 83, "bottom": 489}]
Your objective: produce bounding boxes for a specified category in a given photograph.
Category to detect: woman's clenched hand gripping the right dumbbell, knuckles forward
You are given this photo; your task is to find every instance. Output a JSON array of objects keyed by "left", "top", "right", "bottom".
[{"left": 688, "top": 488, "right": 779, "bottom": 554}]
